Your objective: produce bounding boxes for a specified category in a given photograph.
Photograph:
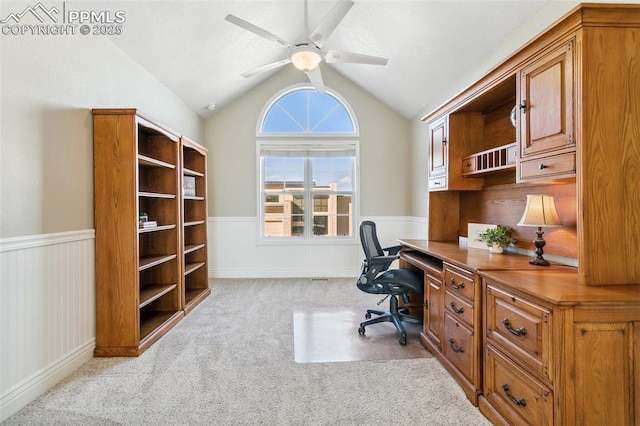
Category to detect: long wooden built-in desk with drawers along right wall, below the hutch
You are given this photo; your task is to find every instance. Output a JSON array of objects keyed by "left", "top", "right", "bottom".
[{"left": 400, "top": 240, "right": 640, "bottom": 425}]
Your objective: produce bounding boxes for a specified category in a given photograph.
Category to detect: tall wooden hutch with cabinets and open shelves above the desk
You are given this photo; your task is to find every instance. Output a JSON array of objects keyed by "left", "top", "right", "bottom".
[{"left": 423, "top": 3, "right": 640, "bottom": 285}]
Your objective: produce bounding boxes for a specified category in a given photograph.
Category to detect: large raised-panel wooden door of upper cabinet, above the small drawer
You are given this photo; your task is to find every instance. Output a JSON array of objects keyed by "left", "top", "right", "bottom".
[{"left": 518, "top": 40, "right": 575, "bottom": 158}]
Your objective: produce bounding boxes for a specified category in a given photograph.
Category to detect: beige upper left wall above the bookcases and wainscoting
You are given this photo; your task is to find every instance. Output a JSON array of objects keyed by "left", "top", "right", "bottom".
[{"left": 0, "top": 34, "right": 204, "bottom": 238}]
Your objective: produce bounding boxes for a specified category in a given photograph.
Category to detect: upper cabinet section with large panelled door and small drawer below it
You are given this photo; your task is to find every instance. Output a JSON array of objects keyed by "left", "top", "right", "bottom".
[{"left": 515, "top": 38, "right": 576, "bottom": 182}]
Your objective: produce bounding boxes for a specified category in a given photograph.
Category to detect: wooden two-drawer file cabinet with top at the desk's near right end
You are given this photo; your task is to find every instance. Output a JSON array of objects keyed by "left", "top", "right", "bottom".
[{"left": 479, "top": 270, "right": 640, "bottom": 425}]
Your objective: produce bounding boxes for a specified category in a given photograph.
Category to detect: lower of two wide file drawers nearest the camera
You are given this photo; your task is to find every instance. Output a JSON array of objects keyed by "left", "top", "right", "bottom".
[{"left": 484, "top": 345, "right": 553, "bottom": 426}]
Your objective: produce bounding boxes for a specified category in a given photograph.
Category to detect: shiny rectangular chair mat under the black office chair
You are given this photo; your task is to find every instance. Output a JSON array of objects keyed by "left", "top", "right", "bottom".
[{"left": 293, "top": 307, "right": 431, "bottom": 363}]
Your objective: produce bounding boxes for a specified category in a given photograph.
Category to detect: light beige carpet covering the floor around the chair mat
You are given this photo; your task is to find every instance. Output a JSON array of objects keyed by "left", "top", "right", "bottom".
[{"left": 5, "top": 279, "right": 489, "bottom": 426}]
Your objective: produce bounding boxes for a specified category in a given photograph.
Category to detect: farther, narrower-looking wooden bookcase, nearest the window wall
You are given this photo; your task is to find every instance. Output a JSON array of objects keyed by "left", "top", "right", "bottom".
[{"left": 180, "top": 137, "right": 211, "bottom": 312}]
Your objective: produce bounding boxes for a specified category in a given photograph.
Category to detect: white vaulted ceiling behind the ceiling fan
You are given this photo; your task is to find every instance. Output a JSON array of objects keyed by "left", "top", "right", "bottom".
[{"left": 104, "top": 0, "right": 575, "bottom": 118}]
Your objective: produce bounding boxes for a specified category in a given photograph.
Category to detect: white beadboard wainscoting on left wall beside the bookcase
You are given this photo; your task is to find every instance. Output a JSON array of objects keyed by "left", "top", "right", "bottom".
[{"left": 0, "top": 230, "right": 95, "bottom": 421}]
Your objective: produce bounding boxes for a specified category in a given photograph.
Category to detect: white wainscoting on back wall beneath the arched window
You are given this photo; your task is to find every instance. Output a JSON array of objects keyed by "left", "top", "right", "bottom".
[{"left": 208, "top": 216, "right": 427, "bottom": 278}]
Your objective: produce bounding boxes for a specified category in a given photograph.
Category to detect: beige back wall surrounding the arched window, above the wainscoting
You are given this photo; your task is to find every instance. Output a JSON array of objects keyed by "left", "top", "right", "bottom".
[{"left": 205, "top": 66, "right": 411, "bottom": 217}]
